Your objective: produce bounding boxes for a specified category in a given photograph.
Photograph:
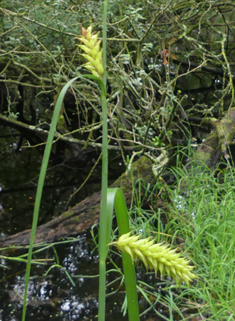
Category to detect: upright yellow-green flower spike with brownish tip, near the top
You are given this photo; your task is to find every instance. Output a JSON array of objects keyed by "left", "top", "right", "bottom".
[{"left": 77, "top": 26, "right": 104, "bottom": 78}]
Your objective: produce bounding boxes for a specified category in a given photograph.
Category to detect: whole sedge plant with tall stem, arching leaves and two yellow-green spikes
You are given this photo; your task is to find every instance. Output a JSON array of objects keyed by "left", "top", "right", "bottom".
[{"left": 22, "top": 0, "right": 195, "bottom": 321}]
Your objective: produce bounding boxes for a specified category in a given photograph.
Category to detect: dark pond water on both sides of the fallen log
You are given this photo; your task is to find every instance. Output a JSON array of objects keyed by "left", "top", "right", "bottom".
[{"left": 0, "top": 127, "right": 130, "bottom": 321}]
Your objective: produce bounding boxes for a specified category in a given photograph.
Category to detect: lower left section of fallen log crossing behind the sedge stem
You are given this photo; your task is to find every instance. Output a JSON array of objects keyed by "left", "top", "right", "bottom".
[{"left": 0, "top": 156, "right": 154, "bottom": 247}]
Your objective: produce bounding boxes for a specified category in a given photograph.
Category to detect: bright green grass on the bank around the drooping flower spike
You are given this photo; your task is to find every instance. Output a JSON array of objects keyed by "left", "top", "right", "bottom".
[{"left": 125, "top": 162, "right": 235, "bottom": 321}]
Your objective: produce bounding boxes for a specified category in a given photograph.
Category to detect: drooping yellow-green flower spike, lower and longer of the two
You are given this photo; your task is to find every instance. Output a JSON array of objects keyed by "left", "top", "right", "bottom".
[{"left": 111, "top": 233, "right": 196, "bottom": 285}]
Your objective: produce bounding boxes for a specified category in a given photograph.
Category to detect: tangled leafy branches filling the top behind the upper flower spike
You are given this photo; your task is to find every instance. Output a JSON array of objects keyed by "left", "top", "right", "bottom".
[{"left": 0, "top": 0, "right": 234, "bottom": 155}]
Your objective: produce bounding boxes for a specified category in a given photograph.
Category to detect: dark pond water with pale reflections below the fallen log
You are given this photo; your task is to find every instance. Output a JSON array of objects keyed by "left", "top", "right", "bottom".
[{"left": 0, "top": 234, "right": 129, "bottom": 321}]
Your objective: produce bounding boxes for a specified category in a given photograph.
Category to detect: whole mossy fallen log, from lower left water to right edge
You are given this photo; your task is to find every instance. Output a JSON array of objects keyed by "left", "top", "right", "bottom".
[{"left": 0, "top": 108, "right": 235, "bottom": 247}]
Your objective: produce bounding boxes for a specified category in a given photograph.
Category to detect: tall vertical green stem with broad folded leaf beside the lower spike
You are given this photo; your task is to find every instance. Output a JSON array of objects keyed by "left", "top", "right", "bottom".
[{"left": 98, "top": 0, "right": 139, "bottom": 321}]
